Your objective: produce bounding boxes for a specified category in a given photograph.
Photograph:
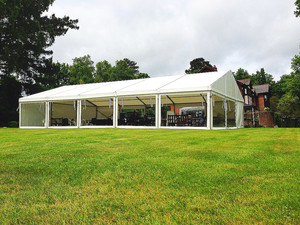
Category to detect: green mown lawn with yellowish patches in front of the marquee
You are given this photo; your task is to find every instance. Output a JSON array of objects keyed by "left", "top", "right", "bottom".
[{"left": 0, "top": 128, "right": 300, "bottom": 224}]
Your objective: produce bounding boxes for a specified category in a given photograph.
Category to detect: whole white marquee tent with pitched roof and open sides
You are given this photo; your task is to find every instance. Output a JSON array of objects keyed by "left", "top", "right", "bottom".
[{"left": 19, "top": 71, "right": 243, "bottom": 129}]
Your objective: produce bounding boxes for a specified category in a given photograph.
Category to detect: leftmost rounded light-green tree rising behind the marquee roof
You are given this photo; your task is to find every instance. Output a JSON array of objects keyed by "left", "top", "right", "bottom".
[{"left": 70, "top": 55, "right": 95, "bottom": 84}]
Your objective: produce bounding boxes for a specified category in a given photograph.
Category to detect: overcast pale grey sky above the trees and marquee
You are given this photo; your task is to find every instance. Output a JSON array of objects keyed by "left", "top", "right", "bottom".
[{"left": 49, "top": 0, "right": 300, "bottom": 80}]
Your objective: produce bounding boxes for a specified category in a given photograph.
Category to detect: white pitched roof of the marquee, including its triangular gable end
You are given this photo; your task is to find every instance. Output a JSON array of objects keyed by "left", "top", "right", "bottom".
[{"left": 19, "top": 71, "right": 243, "bottom": 102}]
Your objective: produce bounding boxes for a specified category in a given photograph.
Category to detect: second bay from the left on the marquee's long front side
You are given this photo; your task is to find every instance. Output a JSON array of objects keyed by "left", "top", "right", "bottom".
[{"left": 49, "top": 100, "right": 77, "bottom": 127}]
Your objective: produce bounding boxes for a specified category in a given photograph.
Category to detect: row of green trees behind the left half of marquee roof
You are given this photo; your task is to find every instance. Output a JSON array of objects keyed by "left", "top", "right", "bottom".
[{"left": 34, "top": 55, "right": 149, "bottom": 92}]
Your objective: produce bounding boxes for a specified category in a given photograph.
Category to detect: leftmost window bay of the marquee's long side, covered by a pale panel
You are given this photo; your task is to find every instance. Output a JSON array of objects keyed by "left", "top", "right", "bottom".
[{"left": 21, "top": 102, "right": 46, "bottom": 127}]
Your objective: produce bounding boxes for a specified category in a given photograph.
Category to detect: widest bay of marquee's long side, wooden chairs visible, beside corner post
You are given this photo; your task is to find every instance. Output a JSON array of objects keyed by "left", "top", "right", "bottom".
[{"left": 161, "top": 93, "right": 207, "bottom": 127}]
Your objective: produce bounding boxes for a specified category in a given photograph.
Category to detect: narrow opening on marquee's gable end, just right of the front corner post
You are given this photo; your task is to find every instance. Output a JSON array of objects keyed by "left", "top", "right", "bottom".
[{"left": 212, "top": 95, "right": 226, "bottom": 127}]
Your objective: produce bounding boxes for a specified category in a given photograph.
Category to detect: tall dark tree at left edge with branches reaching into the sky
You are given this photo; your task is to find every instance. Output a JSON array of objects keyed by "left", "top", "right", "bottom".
[{"left": 0, "top": 0, "right": 78, "bottom": 91}]
